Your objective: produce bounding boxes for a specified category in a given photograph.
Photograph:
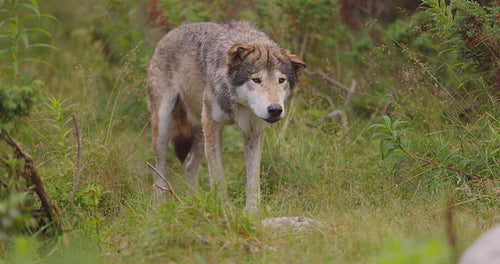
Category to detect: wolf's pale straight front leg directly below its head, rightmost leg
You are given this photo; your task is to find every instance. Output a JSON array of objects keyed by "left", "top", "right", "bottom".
[{"left": 244, "top": 130, "right": 264, "bottom": 211}]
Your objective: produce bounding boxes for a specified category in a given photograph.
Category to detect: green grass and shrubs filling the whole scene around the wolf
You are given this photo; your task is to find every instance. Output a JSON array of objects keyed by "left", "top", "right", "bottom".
[{"left": 0, "top": 0, "right": 500, "bottom": 263}]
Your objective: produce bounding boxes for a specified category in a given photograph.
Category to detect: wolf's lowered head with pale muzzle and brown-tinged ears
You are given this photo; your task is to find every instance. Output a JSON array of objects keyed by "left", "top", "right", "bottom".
[{"left": 226, "top": 43, "right": 306, "bottom": 123}]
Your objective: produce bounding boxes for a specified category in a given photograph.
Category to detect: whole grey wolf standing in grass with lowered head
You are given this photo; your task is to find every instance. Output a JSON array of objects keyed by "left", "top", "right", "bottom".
[{"left": 147, "top": 21, "right": 306, "bottom": 210}]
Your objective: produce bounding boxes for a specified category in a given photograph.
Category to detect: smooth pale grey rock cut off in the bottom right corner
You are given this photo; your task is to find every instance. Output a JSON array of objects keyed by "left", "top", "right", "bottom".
[{"left": 458, "top": 225, "right": 500, "bottom": 264}]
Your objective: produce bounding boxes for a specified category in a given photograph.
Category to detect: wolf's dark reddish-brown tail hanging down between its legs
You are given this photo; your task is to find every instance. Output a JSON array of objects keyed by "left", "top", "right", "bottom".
[{"left": 171, "top": 97, "right": 194, "bottom": 162}]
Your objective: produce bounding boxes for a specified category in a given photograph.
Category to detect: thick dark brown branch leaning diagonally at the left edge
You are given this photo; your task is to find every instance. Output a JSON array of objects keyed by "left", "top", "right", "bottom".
[{"left": 0, "top": 131, "right": 63, "bottom": 233}]
